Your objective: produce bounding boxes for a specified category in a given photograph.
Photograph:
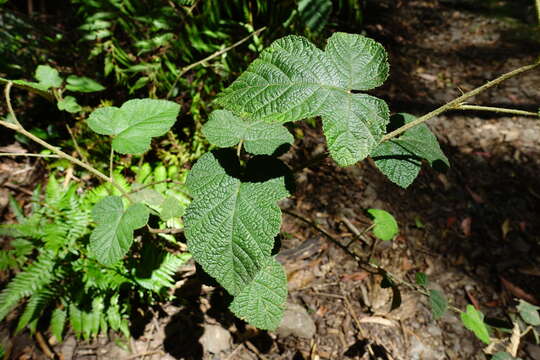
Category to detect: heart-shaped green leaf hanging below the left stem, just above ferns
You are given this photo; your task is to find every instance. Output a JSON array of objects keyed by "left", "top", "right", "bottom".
[{"left": 89, "top": 196, "right": 149, "bottom": 265}]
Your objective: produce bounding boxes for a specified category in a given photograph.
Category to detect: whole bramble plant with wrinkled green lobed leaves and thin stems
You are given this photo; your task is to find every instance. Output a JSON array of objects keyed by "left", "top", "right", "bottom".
[{"left": 0, "top": 33, "right": 540, "bottom": 341}]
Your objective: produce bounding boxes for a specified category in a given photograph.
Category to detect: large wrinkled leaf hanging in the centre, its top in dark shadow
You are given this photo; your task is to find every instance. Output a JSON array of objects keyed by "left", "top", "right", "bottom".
[{"left": 184, "top": 151, "right": 288, "bottom": 295}]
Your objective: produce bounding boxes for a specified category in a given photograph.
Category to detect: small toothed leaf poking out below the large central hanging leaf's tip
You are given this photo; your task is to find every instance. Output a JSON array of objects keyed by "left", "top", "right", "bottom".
[{"left": 230, "top": 257, "right": 287, "bottom": 330}]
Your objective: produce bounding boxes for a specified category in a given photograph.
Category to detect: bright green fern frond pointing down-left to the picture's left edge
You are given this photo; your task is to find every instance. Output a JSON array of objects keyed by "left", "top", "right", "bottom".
[{"left": 0, "top": 254, "right": 54, "bottom": 321}]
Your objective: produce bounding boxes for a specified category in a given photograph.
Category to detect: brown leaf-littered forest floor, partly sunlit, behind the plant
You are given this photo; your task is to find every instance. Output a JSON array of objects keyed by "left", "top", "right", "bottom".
[{"left": 0, "top": 0, "right": 540, "bottom": 360}]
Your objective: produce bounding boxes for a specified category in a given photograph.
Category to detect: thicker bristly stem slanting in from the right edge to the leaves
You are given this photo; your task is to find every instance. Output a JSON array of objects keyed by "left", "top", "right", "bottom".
[{"left": 381, "top": 61, "right": 540, "bottom": 142}]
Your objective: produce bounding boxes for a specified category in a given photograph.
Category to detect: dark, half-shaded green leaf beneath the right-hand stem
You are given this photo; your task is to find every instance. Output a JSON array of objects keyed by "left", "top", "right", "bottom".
[{"left": 371, "top": 113, "right": 450, "bottom": 188}]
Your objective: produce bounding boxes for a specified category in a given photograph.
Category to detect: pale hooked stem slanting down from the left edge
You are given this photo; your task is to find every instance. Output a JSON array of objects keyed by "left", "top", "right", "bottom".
[{"left": 0, "top": 82, "right": 131, "bottom": 201}]
